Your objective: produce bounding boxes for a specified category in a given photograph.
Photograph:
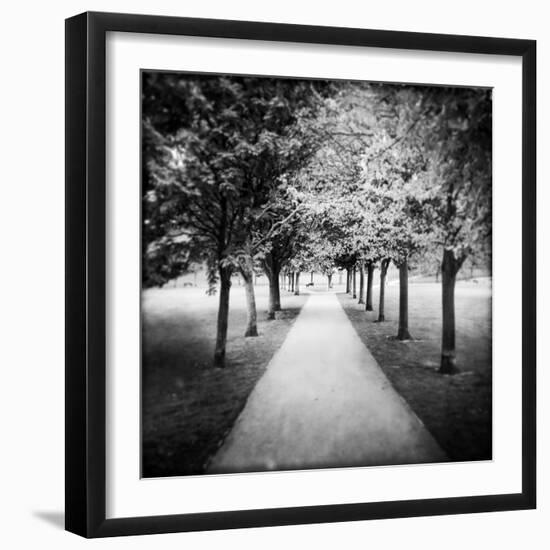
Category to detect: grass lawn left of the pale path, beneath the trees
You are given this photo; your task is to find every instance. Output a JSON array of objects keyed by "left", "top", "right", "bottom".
[{"left": 142, "top": 283, "right": 306, "bottom": 477}]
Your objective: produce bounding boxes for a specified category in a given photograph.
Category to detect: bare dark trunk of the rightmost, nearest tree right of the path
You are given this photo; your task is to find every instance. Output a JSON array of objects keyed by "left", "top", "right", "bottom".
[{"left": 439, "top": 250, "right": 460, "bottom": 374}]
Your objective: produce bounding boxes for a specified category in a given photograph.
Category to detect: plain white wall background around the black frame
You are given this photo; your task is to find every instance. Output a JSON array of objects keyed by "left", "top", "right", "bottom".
[{"left": 0, "top": 0, "right": 550, "bottom": 550}]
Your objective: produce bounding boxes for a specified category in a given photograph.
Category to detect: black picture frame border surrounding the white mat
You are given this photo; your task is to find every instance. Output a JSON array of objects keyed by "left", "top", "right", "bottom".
[{"left": 65, "top": 12, "right": 536, "bottom": 537}]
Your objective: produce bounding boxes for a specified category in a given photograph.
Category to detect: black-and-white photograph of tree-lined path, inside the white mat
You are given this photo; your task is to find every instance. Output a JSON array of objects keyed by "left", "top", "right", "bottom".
[{"left": 141, "top": 70, "right": 493, "bottom": 478}]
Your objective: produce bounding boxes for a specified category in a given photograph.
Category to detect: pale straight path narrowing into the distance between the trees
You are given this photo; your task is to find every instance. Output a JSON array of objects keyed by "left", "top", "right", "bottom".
[{"left": 207, "top": 292, "right": 447, "bottom": 473}]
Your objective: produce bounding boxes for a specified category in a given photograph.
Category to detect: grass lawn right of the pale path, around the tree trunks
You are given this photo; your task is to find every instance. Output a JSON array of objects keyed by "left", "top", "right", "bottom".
[{"left": 338, "top": 280, "right": 492, "bottom": 461}]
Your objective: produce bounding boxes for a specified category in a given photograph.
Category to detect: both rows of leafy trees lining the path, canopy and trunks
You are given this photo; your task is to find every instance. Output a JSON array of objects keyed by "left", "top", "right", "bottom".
[{"left": 142, "top": 72, "right": 492, "bottom": 373}]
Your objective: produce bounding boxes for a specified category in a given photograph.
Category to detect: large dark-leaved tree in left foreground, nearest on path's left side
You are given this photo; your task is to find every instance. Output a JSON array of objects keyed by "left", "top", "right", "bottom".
[{"left": 142, "top": 72, "right": 338, "bottom": 367}]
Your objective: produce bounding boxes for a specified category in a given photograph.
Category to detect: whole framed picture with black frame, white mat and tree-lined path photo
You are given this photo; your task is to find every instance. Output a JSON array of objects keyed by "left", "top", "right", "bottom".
[{"left": 66, "top": 13, "right": 536, "bottom": 537}]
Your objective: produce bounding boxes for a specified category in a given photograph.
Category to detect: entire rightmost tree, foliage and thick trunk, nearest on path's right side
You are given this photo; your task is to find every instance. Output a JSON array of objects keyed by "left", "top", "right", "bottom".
[{"left": 424, "top": 88, "right": 492, "bottom": 374}]
